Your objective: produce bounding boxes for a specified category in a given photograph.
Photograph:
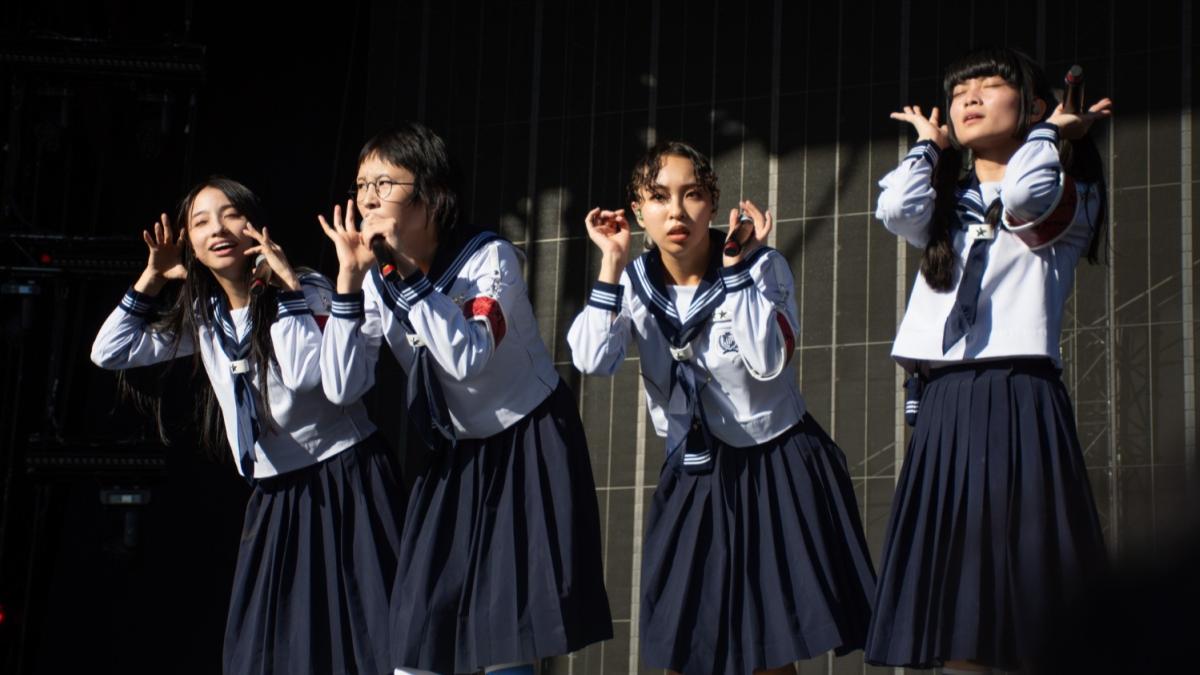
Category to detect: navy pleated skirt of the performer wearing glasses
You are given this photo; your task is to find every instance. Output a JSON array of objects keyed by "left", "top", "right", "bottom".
[{"left": 391, "top": 382, "right": 612, "bottom": 674}]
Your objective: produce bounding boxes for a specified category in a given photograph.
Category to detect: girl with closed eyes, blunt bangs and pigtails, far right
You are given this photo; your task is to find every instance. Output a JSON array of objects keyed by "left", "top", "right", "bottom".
[{"left": 866, "top": 49, "right": 1111, "bottom": 671}]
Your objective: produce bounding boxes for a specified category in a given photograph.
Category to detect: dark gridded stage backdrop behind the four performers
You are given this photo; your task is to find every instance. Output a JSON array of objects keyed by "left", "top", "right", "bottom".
[{"left": 0, "top": 0, "right": 1200, "bottom": 674}]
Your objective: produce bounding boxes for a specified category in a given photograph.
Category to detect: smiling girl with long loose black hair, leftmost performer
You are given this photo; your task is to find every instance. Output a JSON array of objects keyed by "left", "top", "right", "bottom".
[{"left": 91, "top": 178, "right": 402, "bottom": 675}]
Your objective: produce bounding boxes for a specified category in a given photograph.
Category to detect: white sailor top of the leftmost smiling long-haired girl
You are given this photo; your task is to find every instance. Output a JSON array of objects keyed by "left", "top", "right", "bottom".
[{"left": 91, "top": 273, "right": 376, "bottom": 478}]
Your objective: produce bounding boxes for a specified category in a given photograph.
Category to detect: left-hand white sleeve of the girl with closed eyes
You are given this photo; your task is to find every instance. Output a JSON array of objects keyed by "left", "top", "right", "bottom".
[{"left": 875, "top": 141, "right": 940, "bottom": 249}]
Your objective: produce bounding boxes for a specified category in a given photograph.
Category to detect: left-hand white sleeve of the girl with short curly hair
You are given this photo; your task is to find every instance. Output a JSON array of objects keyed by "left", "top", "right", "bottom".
[{"left": 566, "top": 273, "right": 632, "bottom": 375}]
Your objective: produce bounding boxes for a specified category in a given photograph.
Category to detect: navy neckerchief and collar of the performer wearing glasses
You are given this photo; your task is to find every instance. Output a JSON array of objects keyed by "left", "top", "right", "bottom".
[{"left": 371, "top": 231, "right": 500, "bottom": 450}]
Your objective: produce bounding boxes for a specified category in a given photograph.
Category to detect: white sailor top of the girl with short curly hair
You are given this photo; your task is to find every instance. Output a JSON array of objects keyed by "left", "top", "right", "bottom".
[{"left": 568, "top": 239, "right": 805, "bottom": 450}]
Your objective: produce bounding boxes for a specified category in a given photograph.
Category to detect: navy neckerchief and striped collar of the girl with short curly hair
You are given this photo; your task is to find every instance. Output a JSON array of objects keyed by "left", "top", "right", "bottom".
[{"left": 626, "top": 229, "right": 768, "bottom": 473}]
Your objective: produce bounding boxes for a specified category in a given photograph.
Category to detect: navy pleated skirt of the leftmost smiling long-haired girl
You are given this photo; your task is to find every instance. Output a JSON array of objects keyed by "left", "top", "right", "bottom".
[{"left": 224, "top": 435, "right": 403, "bottom": 675}]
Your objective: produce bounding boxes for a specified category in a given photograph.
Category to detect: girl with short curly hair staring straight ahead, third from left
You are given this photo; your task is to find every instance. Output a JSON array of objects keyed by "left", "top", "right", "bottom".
[{"left": 568, "top": 143, "right": 875, "bottom": 675}]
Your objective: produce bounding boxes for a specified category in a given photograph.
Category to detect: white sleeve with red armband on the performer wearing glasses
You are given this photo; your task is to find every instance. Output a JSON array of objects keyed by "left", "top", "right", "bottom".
[{"left": 391, "top": 241, "right": 529, "bottom": 381}]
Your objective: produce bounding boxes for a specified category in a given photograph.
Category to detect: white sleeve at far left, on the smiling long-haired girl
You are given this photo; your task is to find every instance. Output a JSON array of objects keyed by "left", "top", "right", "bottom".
[{"left": 91, "top": 288, "right": 194, "bottom": 370}]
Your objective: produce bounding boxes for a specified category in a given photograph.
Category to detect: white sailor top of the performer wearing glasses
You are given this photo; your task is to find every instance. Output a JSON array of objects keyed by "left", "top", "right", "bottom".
[{"left": 320, "top": 232, "right": 558, "bottom": 438}]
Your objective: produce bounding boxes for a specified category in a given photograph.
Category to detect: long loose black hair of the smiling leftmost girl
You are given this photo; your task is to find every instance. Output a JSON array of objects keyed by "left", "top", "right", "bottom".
[{"left": 120, "top": 175, "right": 278, "bottom": 460}]
